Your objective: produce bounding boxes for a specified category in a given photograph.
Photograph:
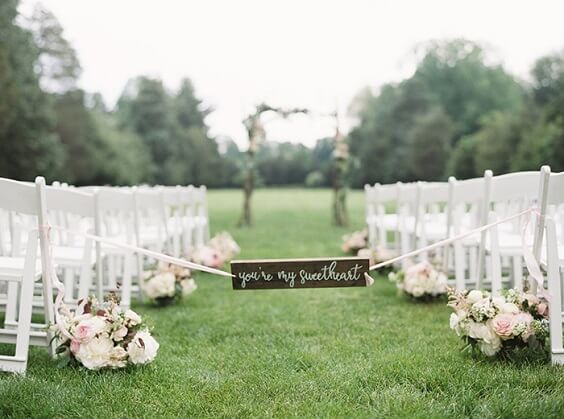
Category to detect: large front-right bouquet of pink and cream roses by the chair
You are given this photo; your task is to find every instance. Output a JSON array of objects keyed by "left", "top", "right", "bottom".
[{"left": 448, "top": 289, "right": 549, "bottom": 356}]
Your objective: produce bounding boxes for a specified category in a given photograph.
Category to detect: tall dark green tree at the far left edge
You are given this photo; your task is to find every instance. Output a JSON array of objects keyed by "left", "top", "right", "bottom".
[{"left": 0, "top": 0, "right": 64, "bottom": 180}]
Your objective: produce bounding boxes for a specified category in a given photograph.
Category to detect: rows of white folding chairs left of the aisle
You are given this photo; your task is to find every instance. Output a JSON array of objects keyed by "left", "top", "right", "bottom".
[{"left": 0, "top": 177, "right": 209, "bottom": 373}]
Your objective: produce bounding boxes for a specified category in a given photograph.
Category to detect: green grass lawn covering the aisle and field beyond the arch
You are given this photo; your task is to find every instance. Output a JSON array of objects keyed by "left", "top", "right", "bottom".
[{"left": 0, "top": 189, "right": 564, "bottom": 417}]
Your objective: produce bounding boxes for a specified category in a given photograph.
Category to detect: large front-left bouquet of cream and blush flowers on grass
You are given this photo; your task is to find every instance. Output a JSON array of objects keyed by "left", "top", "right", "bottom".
[{"left": 55, "top": 295, "right": 159, "bottom": 370}]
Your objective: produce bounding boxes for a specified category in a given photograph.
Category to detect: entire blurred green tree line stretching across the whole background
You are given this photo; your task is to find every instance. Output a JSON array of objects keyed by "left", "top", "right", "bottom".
[{"left": 0, "top": 0, "right": 564, "bottom": 187}]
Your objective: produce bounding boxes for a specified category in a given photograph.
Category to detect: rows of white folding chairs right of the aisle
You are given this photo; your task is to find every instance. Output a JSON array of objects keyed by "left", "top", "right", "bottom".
[{"left": 365, "top": 166, "right": 564, "bottom": 363}]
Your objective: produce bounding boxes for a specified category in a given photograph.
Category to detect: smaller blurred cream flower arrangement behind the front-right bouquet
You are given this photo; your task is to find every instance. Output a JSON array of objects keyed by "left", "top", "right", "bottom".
[{"left": 388, "top": 261, "right": 448, "bottom": 301}]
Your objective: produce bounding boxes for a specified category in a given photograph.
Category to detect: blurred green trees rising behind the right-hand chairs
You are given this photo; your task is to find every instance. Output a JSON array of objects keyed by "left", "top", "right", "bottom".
[{"left": 349, "top": 39, "right": 564, "bottom": 186}]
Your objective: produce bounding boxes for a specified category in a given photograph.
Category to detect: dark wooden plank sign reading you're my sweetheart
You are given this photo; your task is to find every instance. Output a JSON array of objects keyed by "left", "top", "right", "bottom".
[{"left": 231, "top": 258, "right": 373, "bottom": 290}]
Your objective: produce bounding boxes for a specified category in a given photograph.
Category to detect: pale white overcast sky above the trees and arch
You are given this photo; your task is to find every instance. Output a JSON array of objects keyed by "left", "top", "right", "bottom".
[{"left": 22, "top": 0, "right": 564, "bottom": 145}]
